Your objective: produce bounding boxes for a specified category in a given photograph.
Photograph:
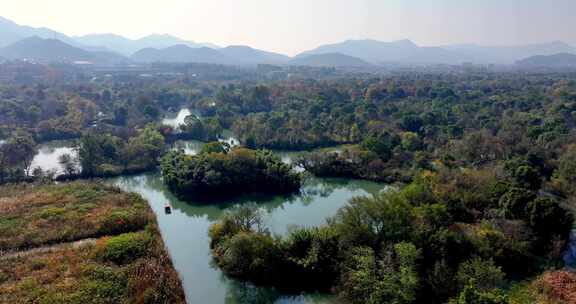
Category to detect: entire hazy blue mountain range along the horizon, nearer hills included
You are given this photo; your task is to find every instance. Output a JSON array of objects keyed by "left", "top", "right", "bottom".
[{"left": 0, "top": 17, "right": 576, "bottom": 66}]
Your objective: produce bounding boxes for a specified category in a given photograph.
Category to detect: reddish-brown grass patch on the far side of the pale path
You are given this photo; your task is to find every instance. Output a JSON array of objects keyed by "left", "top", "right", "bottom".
[{"left": 0, "top": 182, "right": 151, "bottom": 251}]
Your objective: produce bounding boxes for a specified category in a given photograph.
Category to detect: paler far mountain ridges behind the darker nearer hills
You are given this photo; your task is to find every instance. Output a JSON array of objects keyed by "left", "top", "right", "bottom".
[{"left": 0, "top": 17, "right": 576, "bottom": 65}]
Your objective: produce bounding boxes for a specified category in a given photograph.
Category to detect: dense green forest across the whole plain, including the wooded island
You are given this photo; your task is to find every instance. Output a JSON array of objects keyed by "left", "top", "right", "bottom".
[{"left": 0, "top": 65, "right": 576, "bottom": 304}]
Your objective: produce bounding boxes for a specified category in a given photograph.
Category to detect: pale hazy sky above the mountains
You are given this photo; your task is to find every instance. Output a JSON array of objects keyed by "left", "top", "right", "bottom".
[{"left": 0, "top": 0, "right": 576, "bottom": 55}]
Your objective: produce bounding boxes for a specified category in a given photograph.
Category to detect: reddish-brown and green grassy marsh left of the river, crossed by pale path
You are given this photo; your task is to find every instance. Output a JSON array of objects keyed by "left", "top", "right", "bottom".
[{"left": 0, "top": 182, "right": 185, "bottom": 304}]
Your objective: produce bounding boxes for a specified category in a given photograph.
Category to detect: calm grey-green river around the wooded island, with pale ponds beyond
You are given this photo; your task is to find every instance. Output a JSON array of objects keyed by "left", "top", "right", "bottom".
[{"left": 34, "top": 109, "right": 386, "bottom": 304}]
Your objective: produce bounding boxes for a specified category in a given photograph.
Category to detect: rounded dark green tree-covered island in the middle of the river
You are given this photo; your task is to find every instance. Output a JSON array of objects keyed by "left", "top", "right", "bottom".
[{"left": 161, "top": 142, "right": 302, "bottom": 199}]
